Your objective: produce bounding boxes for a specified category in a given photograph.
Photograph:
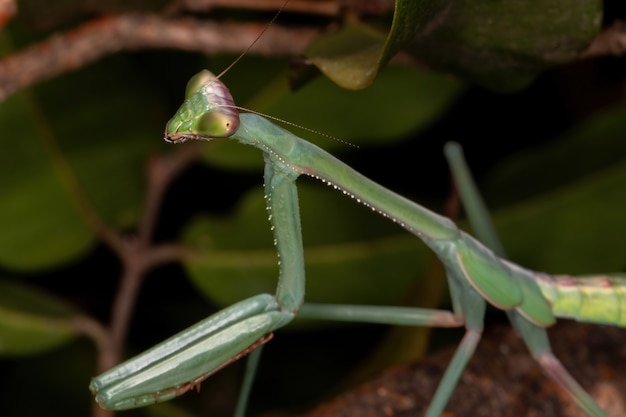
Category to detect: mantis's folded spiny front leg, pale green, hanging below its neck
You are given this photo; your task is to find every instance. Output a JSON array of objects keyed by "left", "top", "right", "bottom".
[{"left": 89, "top": 154, "right": 305, "bottom": 410}]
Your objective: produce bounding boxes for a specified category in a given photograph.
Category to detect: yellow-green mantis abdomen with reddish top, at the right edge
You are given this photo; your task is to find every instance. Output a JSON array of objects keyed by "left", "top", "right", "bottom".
[{"left": 536, "top": 273, "right": 626, "bottom": 327}]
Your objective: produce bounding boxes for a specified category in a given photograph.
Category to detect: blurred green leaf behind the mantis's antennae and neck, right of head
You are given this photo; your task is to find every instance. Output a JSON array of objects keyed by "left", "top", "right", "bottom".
[{"left": 205, "top": 67, "right": 464, "bottom": 169}]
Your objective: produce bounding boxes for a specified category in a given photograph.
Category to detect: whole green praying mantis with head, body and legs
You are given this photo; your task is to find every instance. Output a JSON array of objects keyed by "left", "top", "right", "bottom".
[{"left": 90, "top": 66, "right": 626, "bottom": 417}]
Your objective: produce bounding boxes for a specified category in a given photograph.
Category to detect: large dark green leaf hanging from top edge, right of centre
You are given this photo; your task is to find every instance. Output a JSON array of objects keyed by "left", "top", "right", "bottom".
[{"left": 408, "top": 0, "right": 602, "bottom": 91}]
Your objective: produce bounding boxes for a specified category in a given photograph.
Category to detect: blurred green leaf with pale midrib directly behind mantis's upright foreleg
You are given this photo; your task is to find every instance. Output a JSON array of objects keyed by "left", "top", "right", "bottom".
[{"left": 183, "top": 183, "right": 428, "bottom": 316}]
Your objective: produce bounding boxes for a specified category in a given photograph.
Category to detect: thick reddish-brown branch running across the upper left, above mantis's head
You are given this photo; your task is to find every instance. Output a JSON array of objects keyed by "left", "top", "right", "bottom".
[{"left": 0, "top": 14, "right": 319, "bottom": 101}]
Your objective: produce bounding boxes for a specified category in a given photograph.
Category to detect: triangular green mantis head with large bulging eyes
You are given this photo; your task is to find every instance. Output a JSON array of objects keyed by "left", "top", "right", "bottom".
[{"left": 165, "top": 70, "right": 239, "bottom": 143}]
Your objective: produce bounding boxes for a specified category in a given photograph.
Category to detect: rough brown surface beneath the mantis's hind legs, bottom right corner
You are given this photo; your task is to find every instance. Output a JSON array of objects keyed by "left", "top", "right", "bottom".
[{"left": 304, "top": 321, "right": 626, "bottom": 417}]
